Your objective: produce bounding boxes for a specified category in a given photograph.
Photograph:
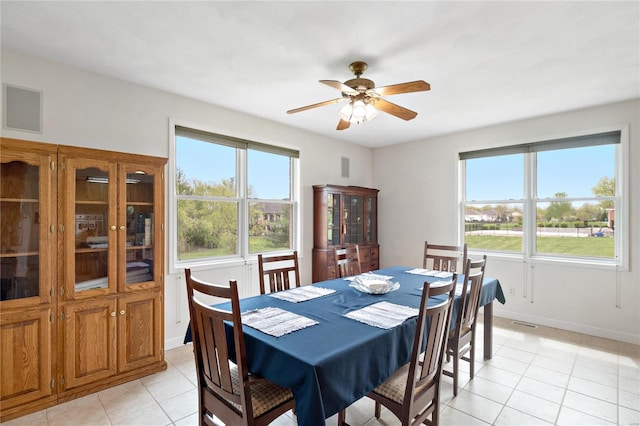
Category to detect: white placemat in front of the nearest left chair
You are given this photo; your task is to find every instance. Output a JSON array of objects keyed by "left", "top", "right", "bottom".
[{"left": 241, "top": 307, "right": 318, "bottom": 337}]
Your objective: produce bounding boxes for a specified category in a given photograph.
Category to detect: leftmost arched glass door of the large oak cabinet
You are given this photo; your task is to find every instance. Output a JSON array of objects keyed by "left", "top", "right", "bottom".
[{"left": 0, "top": 152, "right": 53, "bottom": 303}]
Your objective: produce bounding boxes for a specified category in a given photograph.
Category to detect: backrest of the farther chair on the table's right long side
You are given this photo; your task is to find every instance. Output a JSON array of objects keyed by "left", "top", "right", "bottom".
[{"left": 453, "top": 254, "right": 487, "bottom": 336}]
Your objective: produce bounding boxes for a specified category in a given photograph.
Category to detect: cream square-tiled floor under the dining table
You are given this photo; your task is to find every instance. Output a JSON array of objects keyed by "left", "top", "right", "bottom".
[{"left": 3, "top": 318, "right": 640, "bottom": 426}]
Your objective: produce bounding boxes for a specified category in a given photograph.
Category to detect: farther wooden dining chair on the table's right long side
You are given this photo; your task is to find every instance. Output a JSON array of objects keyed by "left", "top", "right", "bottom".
[{"left": 443, "top": 254, "right": 487, "bottom": 396}]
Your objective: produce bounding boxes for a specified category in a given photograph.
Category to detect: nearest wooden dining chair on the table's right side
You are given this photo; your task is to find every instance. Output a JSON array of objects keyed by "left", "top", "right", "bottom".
[{"left": 338, "top": 273, "right": 457, "bottom": 426}]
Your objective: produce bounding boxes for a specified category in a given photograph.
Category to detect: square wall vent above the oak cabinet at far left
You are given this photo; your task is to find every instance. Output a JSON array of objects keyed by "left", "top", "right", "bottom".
[{"left": 2, "top": 84, "right": 42, "bottom": 133}]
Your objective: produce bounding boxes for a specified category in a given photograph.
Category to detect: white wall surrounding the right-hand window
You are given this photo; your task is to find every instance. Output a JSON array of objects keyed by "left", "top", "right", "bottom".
[{"left": 373, "top": 99, "right": 640, "bottom": 344}]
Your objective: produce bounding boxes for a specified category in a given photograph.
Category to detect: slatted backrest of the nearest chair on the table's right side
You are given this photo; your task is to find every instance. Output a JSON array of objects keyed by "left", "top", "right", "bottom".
[{"left": 402, "top": 273, "right": 458, "bottom": 424}]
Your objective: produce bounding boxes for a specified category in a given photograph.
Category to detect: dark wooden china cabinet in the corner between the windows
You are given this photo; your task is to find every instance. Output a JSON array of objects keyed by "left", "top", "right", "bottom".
[{"left": 312, "top": 185, "right": 380, "bottom": 282}]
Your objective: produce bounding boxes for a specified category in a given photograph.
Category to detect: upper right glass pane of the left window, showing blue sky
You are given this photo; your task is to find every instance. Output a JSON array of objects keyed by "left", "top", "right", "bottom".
[{"left": 247, "top": 149, "right": 291, "bottom": 200}]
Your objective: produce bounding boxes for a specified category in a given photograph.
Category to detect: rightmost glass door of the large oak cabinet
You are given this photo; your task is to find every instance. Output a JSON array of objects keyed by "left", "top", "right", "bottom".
[{"left": 119, "top": 164, "right": 160, "bottom": 288}]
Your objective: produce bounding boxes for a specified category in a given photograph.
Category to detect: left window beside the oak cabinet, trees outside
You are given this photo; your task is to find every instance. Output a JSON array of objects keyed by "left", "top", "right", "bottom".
[{"left": 172, "top": 126, "right": 298, "bottom": 265}]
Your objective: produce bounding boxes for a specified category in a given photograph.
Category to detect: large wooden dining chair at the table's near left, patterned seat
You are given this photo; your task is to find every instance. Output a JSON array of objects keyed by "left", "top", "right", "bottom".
[{"left": 185, "top": 269, "right": 295, "bottom": 426}]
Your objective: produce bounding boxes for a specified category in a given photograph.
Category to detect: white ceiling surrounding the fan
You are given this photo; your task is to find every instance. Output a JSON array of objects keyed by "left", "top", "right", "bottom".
[{"left": 0, "top": 0, "right": 640, "bottom": 147}]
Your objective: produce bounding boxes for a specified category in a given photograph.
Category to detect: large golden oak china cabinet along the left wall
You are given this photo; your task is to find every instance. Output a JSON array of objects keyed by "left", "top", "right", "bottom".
[{"left": 0, "top": 138, "right": 166, "bottom": 421}]
